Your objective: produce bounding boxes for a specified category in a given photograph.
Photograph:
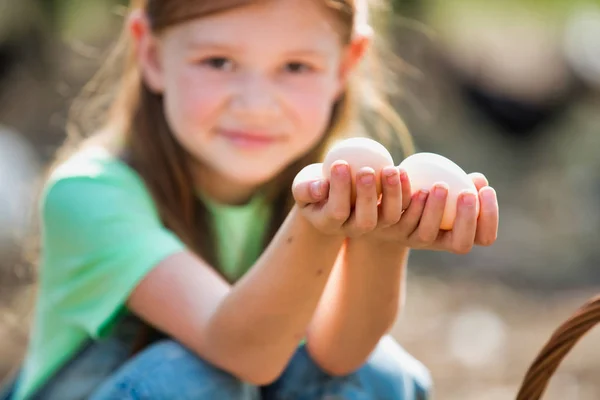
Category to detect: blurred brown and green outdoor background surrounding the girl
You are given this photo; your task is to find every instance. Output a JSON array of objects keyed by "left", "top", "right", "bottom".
[{"left": 0, "top": 0, "right": 600, "bottom": 400}]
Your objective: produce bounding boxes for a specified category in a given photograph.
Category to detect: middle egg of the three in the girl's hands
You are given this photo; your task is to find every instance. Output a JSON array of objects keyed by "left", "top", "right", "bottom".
[{"left": 323, "top": 137, "right": 394, "bottom": 202}]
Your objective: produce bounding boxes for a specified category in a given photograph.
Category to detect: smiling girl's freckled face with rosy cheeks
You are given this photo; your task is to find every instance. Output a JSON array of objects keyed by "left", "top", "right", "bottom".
[{"left": 138, "top": 0, "right": 366, "bottom": 201}]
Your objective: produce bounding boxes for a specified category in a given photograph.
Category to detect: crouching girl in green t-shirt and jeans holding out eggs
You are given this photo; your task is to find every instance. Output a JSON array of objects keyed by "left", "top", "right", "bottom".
[{"left": 4, "top": 0, "right": 498, "bottom": 400}]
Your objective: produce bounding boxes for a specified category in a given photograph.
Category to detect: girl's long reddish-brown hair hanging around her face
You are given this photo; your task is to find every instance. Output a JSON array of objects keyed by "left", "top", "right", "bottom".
[{"left": 57, "top": 0, "right": 412, "bottom": 346}]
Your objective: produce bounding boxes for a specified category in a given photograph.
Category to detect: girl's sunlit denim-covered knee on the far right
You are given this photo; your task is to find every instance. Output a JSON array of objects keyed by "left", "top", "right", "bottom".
[{"left": 365, "top": 336, "right": 432, "bottom": 400}]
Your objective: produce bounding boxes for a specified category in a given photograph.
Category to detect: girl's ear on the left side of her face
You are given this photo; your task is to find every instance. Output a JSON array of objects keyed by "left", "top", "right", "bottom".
[{"left": 127, "top": 10, "right": 164, "bottom": 93}]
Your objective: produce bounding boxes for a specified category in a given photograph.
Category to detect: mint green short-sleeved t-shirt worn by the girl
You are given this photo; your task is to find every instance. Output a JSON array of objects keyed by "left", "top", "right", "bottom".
[{"left": 15, "top": 148, "right": 270, "bottom": 400}]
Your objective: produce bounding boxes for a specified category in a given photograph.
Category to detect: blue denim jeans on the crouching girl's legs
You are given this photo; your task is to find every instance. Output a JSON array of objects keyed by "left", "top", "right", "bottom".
[{"left": 0, "top": 316, "right": 431, "bottom": 400}]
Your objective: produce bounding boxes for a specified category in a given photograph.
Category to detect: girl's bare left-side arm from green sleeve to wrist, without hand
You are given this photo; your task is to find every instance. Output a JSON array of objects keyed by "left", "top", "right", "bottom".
[{"left": 128, "top": 208, "right": 343, "bottom": 385}]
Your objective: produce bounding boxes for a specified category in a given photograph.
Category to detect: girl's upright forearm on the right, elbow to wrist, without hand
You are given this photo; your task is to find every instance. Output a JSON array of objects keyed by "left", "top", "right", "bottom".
[{"left": 308, "top": 239, "right": 408, "bottom": 375}]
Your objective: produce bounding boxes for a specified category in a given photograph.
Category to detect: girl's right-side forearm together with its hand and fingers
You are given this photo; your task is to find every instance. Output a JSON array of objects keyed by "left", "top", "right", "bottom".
[{"left": 308, "top": 174, "right": 498, "bottom": 375}]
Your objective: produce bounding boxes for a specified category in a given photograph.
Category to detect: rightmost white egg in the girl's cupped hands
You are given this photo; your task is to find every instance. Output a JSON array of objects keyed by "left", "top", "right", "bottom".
[{"left": 400, "top": 153, "right": 479, "bottom": 230}]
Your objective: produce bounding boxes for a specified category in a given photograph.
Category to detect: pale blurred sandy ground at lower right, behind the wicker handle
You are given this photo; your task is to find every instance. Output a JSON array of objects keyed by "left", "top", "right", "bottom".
[{"left": 394, "top": 276, "right": 600, "bottom": 400}]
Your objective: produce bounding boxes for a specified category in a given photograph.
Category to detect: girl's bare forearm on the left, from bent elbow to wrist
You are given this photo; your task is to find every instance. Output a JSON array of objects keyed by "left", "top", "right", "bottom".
[{"left": 205, "top": 209, "right": 343, "bottom": 381}]
